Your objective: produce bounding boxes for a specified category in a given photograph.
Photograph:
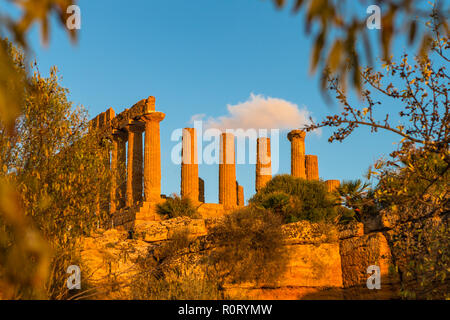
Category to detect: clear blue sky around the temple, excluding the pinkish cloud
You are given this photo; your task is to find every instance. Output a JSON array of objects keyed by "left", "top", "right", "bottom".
[{"left": 2, "top": 0, "right": 414, "bottom": 202}]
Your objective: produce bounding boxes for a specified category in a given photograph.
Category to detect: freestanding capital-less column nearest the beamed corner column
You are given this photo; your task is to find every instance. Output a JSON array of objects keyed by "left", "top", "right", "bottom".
[{"left": 181, "top": 128, "right": 199, "bottom": 202}]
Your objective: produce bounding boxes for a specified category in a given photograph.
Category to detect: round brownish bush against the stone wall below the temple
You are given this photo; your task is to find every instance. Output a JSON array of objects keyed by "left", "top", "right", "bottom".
[{"left": 209, "top": 206, "right": 288, "bottom": 284}]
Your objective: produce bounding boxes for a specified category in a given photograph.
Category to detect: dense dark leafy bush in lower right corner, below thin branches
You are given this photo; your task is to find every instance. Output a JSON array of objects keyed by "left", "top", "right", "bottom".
[{"left": 373, "top": 148, "right": 450, "bottom": 299}]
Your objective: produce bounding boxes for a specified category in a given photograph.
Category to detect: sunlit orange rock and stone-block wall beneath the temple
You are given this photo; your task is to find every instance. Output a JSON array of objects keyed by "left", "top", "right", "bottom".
[{"left": 82, "top": 217, "right": 398, "bottom": 299}]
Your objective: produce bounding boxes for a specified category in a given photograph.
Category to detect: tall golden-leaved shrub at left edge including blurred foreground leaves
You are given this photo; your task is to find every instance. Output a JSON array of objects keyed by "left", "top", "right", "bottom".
[{"left": 0, "top": 41, "right": 111, "bottom": 299}]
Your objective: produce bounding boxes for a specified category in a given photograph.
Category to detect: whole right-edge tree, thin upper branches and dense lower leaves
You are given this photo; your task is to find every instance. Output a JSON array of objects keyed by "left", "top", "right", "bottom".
[{"left": 307, "top": 11, "right": 450, "bottom": 298}]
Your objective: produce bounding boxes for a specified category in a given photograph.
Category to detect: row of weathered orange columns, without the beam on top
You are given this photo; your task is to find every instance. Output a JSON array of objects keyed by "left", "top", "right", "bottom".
[{"left": 111, "top": 124, "right": 339, "bottom": 211}]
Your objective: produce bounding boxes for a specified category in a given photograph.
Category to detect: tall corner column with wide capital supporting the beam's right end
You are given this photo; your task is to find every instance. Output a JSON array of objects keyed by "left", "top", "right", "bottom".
[{"left": 141, "top": 111, "right": 166, "bottom": 201}]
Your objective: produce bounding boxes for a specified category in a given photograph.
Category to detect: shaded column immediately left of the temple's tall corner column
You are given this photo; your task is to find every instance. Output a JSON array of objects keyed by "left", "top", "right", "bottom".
[{"left": 126, "top": 123, "right": 142, "bottom": 207}]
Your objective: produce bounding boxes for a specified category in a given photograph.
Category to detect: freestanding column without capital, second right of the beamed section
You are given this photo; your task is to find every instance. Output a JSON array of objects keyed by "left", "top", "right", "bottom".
[{"left": 219, "top": 133, "right": 237, "bottom": 208}]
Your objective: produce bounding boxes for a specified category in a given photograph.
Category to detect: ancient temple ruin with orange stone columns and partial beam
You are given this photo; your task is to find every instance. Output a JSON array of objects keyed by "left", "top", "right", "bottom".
[{"left": 90, "top": 96, "right": 339, "bottom": 223}]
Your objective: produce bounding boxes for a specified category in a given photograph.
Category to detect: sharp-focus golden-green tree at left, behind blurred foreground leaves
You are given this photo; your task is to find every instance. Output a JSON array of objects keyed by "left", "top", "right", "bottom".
[{"left": 0, "top": 40, "right": 110, "bottom": 299}]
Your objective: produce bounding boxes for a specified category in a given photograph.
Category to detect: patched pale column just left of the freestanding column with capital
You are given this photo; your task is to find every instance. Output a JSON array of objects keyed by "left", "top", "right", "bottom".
[{"left": 255, "top": 138, "right": 272, "bottom": 192}]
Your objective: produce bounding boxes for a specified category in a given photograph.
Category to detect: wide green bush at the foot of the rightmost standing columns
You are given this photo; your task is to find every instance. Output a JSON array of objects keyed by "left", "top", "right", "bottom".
[{"left": 249, "top": 175, "right": 337, "bottom": 222}]
